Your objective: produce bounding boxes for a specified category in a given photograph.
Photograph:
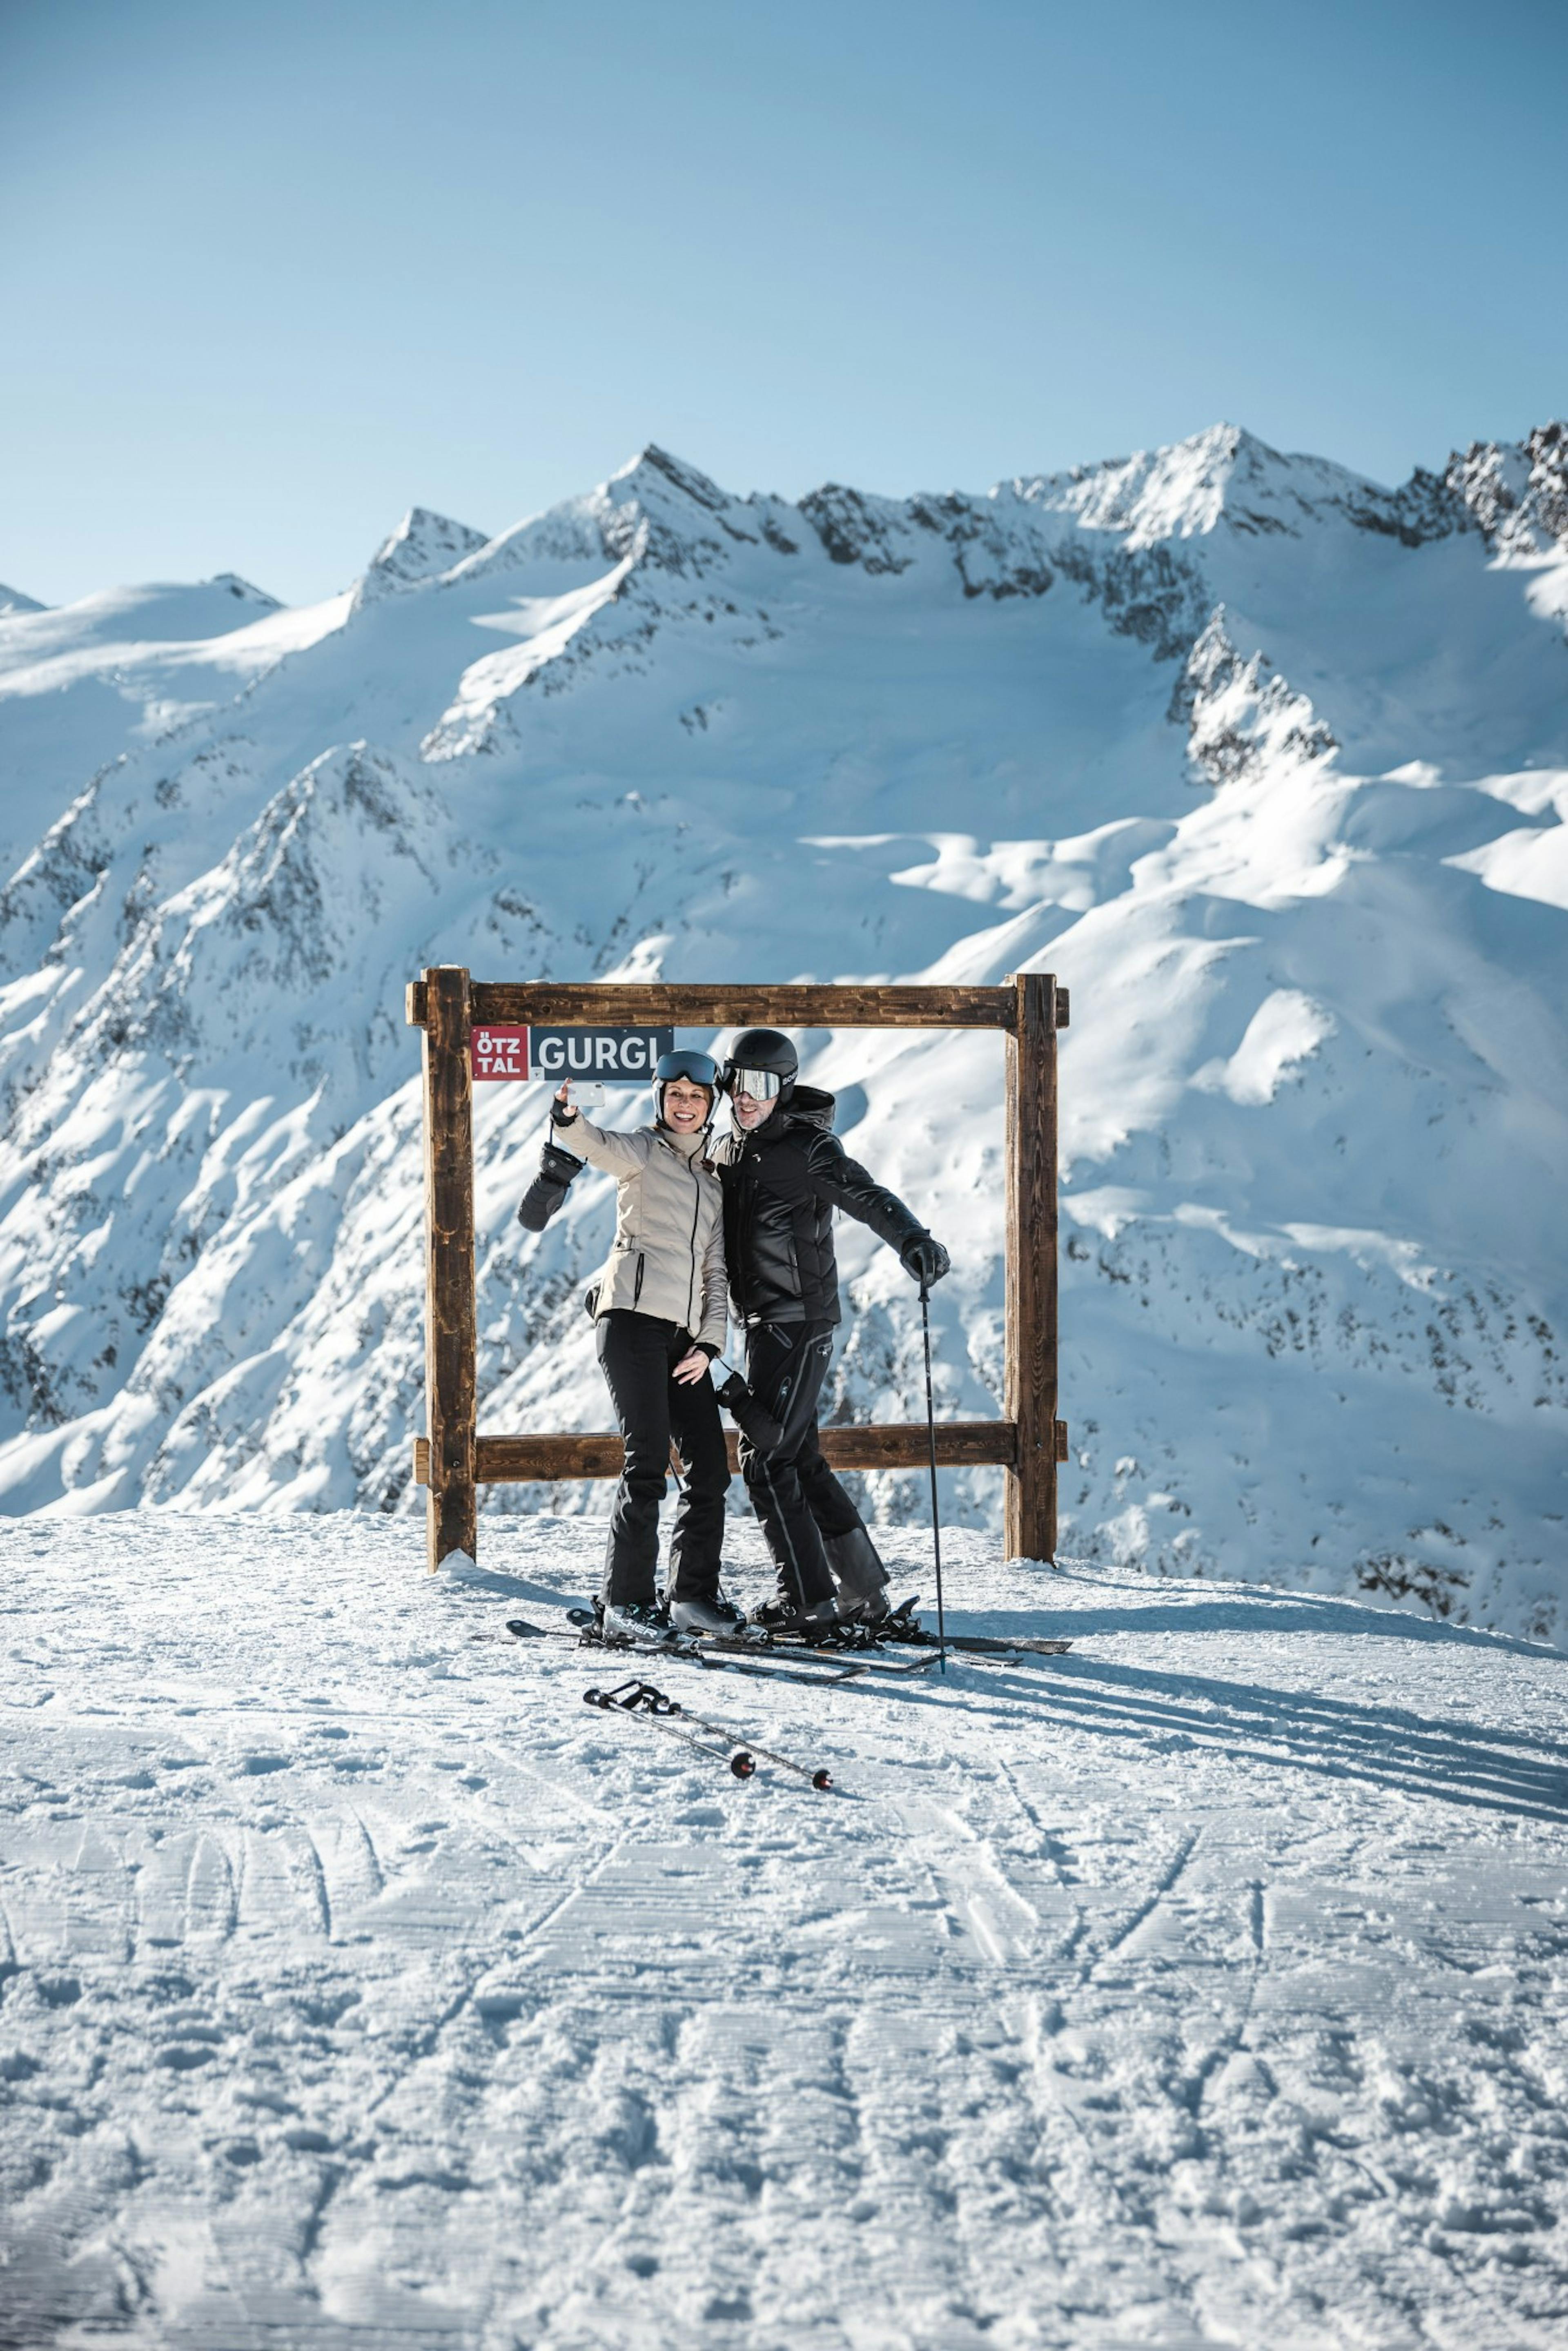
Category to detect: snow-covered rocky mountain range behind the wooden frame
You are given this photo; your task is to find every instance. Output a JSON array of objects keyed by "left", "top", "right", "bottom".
[{"left": 0, "top": 426, "right": 1568, "bottom": 1639}]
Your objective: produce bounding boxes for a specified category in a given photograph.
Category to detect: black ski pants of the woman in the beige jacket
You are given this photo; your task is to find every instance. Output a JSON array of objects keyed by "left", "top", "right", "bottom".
[{"left": 595, "top": 1307, "right": 729, "bottom": 1601}]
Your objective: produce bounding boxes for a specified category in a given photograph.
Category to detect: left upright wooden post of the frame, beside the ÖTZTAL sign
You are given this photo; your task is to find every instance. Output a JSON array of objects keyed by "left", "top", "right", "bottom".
[{"left": 411, "top": 964, "right": 477, "bottom": 1571}]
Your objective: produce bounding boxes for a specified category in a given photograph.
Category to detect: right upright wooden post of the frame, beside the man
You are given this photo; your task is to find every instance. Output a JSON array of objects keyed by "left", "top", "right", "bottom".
[{"left": 1004, "top": 971, "right": 1058, "bottom": 1559}]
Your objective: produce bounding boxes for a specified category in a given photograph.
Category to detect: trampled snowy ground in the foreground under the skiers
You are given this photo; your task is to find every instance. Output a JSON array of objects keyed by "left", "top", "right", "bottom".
[{"left": 0, "top": 1514, "right": 1568, "bottom": 2351}]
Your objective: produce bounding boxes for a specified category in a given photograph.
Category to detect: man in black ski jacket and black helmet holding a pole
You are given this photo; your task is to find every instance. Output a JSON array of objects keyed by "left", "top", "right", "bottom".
[{"left": 715, "top": 1030, "right": 947, "bottom": 1625}]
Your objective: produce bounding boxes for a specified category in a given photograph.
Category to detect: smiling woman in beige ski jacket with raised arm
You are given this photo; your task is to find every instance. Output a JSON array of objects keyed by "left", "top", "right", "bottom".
[{"left": 550, "top": 1053, "right": 745, "bottom": 1648}]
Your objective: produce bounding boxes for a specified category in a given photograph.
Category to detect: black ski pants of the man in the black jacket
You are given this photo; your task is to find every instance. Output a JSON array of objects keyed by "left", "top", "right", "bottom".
[{"left": 740, "top": 1324, "right": 860, "bottom": 1608}]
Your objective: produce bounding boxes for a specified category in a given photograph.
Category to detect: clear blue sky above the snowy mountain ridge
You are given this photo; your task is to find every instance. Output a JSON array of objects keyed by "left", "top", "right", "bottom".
[{"left": 0, "top": 0, "right": 1568, "bottom": 602}]
